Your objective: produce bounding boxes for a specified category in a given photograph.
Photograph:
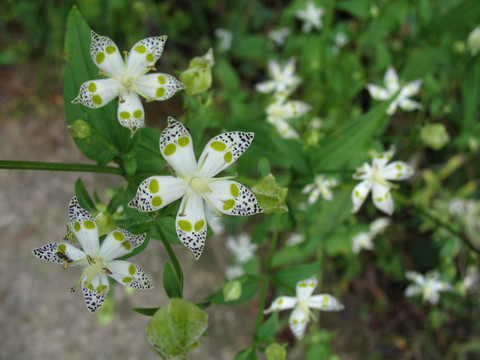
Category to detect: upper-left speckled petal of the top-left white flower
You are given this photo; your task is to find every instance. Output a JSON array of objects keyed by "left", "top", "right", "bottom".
[{"left": 90, "top": 31, "right": 125, "bottom": 77}]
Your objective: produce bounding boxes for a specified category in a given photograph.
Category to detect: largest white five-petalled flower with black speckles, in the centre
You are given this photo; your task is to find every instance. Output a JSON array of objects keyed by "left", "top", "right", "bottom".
[{"left": 128, "top": 117, "right": 262, "bottom": 259}]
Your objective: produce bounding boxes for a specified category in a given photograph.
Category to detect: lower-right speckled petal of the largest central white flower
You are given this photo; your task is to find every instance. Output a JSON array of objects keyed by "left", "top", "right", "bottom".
[{"left": 205, "top": 180, "right": 263, "bottom": 216}]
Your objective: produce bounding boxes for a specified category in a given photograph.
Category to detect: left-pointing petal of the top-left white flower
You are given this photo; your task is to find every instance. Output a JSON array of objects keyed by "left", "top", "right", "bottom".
[{"left": 72, "top": 79, "right": 120, "bottom": 109}]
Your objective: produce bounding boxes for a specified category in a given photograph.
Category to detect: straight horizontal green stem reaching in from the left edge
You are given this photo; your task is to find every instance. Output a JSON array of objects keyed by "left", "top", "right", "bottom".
[{"left": 0, "top": 160, "right": 123, "bottom": 175}]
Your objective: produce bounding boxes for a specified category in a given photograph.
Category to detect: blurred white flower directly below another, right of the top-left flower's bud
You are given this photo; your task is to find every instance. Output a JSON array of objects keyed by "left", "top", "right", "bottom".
[{"left": 266, "top": 97, "right": 312, "bottom": 139}]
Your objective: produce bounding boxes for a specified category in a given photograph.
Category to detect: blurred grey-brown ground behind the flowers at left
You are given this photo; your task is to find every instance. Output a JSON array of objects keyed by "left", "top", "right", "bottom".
[{"left": 0, "top": 72, "right": 256, "bottom": 360}]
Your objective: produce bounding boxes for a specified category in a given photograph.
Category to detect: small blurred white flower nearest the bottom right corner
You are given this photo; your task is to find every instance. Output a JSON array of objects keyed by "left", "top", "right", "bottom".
[{"left": 405, "top": 271, "right": 454, "bottom": 305}]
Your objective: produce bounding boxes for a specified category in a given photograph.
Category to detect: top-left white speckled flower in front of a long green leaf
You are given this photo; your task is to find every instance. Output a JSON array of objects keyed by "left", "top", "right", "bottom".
[{"left": 72, "top": 31, "right": 185, "bottom": 136}]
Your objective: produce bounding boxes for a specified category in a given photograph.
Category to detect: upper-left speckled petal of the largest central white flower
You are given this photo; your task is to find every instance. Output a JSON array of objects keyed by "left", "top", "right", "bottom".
[{"left": 160, "top": 117, "right": 197, "bottom": 176}]
